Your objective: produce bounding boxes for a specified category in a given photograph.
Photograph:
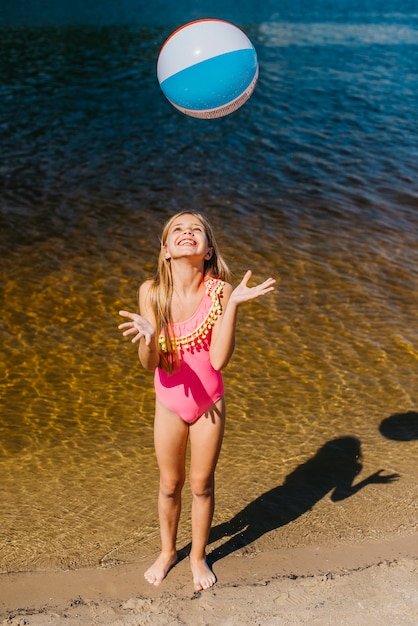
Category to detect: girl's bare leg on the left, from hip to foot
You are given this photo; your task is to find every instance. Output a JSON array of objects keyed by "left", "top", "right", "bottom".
[{"left": 144, "top": 400, "right": 189, "bottom": 585}]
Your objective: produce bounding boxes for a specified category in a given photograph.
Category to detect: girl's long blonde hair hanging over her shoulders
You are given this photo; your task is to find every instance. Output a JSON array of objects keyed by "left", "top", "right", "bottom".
[{"left": 149, "top": 211, "right": 231, "bottom": 372}]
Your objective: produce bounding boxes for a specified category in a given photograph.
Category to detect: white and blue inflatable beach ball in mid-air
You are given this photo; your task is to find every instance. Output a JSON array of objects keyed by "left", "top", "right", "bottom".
[{"left": 157, "top": 19, "right": 258, "bottom": 119}]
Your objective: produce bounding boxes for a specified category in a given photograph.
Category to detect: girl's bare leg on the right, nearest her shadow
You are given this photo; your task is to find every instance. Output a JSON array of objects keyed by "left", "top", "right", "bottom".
[{"left": 190, "top": 398, "right": 225, "bottom": 591}]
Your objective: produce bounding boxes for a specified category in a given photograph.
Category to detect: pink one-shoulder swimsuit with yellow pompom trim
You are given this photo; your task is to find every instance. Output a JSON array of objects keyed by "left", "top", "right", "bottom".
[{"left": 154, "top": 278, "right": 225, "bottom": 424}]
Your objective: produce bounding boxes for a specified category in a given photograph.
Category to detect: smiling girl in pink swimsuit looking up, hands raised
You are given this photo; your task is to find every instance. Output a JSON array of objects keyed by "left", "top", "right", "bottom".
[{"left": 119, "top": 211, "right": 275, "bottom": 591}]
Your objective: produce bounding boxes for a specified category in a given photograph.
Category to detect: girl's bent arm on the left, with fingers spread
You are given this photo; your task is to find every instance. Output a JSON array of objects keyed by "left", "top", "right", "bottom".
[{"left": 118, "top": 280, "right": 160, "bottom": 372}]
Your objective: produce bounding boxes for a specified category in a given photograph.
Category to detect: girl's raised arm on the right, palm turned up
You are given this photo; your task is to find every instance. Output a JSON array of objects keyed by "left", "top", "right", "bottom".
[{"left": 210, "top": 270, "right": 276, "bottom": 370}]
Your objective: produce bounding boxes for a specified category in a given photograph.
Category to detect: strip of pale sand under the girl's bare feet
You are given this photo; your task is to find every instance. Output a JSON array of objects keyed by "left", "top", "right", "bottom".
[{"left": 0, "top": 535, "right": 418, "bottom": 626}]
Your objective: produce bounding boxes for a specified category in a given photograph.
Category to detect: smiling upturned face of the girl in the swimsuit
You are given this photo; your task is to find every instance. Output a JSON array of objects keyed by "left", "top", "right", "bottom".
[{"left": 162, "top": 213, "right": 213, "bottom": 260}]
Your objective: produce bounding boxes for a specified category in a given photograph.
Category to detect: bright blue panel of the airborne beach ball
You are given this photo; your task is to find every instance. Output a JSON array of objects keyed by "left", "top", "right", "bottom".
[{"left": 161, "top": 49, "right": 257, "bottom": 111}]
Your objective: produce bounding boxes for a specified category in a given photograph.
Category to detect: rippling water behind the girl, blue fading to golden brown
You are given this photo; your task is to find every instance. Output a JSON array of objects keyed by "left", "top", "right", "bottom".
[{"left": 0, "top": 2, "right": 418, "bottom": 571}]
